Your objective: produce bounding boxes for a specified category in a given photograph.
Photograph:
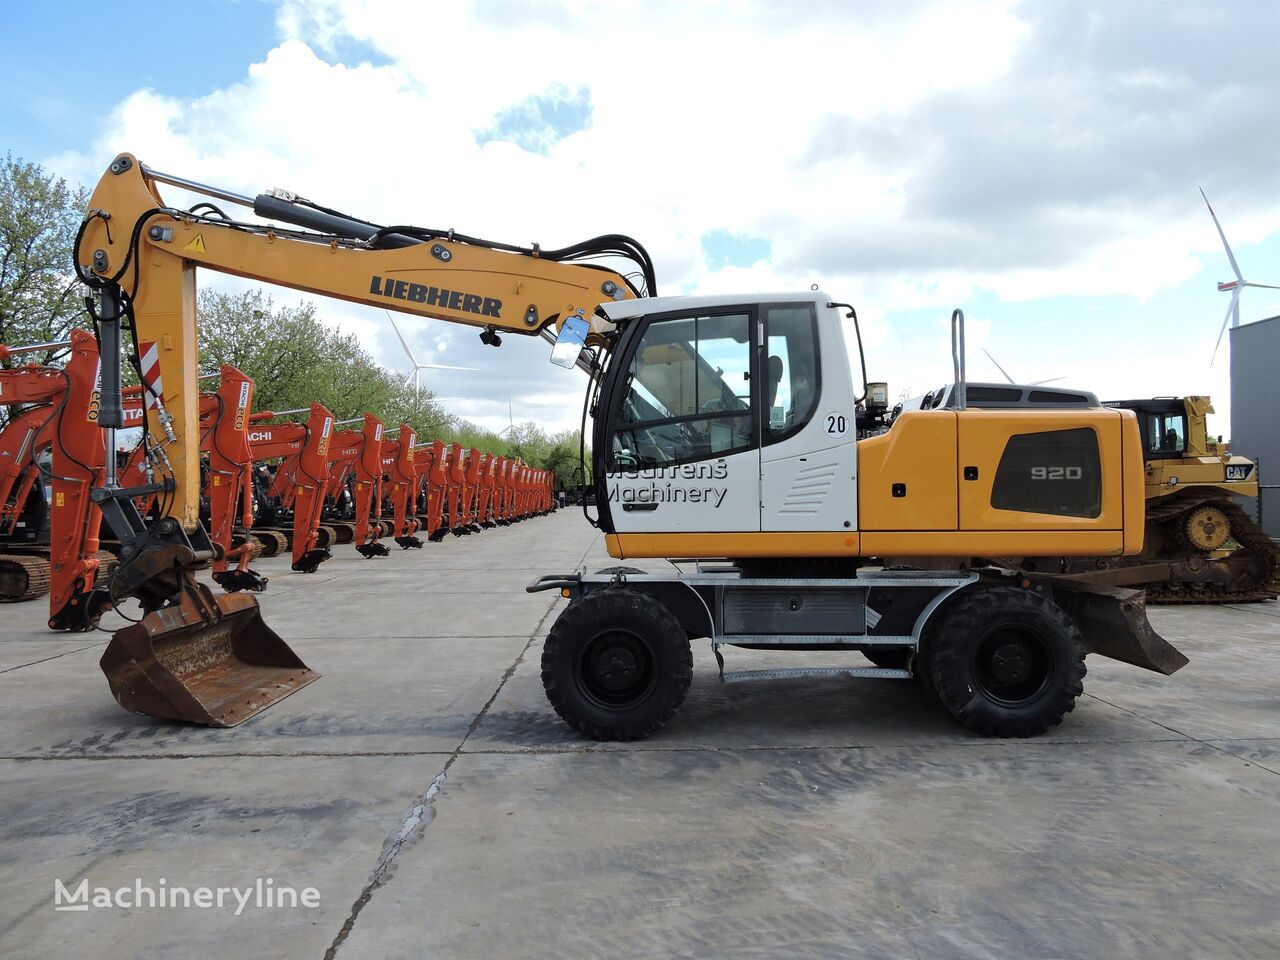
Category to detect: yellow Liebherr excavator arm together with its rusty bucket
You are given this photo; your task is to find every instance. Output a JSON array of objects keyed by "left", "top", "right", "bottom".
[{"left": 74, "top": 154, "right": 655, "bottom": 724}]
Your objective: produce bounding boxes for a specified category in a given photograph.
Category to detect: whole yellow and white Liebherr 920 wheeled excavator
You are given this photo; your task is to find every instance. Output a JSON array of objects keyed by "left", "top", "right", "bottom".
[{"left": 77, "top": 154, "right": 1187, "bottom": 740}]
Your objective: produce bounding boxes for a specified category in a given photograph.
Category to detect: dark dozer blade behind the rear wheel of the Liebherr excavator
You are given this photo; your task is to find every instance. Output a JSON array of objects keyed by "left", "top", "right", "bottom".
[{"left": 1053, "top": 580, "right": 1189, "bottom": 677}]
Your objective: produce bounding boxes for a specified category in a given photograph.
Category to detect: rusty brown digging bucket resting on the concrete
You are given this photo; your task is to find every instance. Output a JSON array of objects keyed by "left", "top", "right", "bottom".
[{"left": 101, "top": 580, "right": 320, "bottom": 727}]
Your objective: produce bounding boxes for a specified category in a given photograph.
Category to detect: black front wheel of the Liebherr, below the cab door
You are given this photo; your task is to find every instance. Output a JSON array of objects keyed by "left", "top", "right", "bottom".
[{"left": 541, "top": 586, "right": 694, "bottom": 740}]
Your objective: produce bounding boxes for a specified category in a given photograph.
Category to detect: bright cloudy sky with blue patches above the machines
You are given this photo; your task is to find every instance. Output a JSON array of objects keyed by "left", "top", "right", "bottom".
[{"left": 0, "top": 0, "right": 1280, "bottom": 433}]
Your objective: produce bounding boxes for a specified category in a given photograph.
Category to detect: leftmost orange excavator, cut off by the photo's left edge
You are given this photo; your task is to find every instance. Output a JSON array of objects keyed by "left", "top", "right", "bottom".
[{"left": 0, "top": 330, "right": 111, "bottom": 631}]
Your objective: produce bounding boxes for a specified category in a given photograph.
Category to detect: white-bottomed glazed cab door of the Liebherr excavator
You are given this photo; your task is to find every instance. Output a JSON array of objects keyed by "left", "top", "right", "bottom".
[{"left": 596, "top": 306, "right": 760, "bottom": 534}]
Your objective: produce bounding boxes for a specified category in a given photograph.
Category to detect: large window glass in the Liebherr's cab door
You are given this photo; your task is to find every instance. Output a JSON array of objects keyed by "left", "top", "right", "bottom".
[{"left": 611, "top": 314, "right": 754, "bottom": 468}]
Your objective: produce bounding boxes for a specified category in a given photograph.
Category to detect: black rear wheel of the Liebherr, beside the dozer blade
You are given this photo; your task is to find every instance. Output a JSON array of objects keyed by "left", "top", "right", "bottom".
[{"left": 922, "top": 586, "right": 1085, "bottom": 737}]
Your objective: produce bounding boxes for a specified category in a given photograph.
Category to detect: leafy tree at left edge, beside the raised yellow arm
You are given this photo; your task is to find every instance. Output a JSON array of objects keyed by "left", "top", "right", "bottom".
[{"left": 0, "top": 154, "right": 88, "bottom": 365}]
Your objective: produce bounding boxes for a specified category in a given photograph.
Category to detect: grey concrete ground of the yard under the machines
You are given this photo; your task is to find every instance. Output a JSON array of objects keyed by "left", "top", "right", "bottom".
[{"left": 0, "top": 511, "right": 1280, "bottom": 960}]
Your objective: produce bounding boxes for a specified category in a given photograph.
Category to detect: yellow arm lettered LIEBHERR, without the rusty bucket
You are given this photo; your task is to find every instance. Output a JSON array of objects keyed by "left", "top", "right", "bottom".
[{"left": 76, "top": 154, "right": 640, "bottom": 532}]
